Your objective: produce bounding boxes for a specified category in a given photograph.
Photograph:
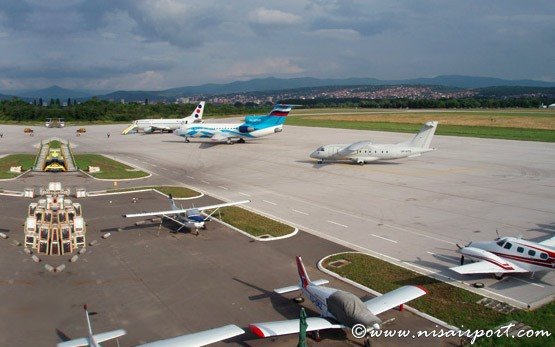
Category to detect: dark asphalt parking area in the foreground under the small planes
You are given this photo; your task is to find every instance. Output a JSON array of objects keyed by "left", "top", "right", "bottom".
[{"left": 0, "top": 192, "right": 456, "bottom": 347}]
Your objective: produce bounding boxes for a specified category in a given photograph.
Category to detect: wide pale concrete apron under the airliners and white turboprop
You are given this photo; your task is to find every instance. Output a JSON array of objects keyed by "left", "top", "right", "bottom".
[{"left": 0, "top": 124, "right": 555, "bottom": 307}]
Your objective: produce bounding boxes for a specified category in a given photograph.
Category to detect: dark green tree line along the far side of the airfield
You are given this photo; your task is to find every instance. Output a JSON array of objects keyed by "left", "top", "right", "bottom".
[{"left": 0, "top": 98, "right": 554, "bottom": 122}]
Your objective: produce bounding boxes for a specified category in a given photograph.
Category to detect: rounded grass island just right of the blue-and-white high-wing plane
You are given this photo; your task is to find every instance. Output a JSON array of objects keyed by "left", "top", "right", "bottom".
[{"left": 208, "top": 206, "right": 295, "bottom": 237}]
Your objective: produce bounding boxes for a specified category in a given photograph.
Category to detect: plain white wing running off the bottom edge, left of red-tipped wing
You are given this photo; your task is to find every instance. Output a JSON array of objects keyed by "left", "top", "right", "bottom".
[{"left": 141, "top": 324, "right": 245, "bottom": 347}]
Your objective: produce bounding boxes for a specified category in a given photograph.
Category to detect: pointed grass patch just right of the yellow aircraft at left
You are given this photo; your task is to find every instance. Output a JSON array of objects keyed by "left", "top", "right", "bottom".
[{"left": 74, "top": 154, "right": 148, "bottom": 180}]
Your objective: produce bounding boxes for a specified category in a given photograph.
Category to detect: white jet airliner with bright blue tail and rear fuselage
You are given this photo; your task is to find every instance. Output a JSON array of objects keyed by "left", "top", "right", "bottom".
[{"left": 174, "top": 104, "right": 296, "bottom": 144}]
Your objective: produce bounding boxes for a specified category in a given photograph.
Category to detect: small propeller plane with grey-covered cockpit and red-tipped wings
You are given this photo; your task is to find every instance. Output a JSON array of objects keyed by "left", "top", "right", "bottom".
[{"left": 249, "top": 257, "right": 427, "bottom": 344}]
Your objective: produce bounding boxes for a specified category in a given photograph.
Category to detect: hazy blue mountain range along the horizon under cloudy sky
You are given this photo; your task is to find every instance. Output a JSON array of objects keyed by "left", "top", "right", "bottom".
[{"left": 0, "top": 75, "right": 555, "bottom": 101}]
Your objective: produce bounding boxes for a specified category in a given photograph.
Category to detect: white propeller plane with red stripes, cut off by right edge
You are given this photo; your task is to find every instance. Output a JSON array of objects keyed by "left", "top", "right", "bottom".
[{"left": 451, "top": 237, "right": 555, "bottom": 279}]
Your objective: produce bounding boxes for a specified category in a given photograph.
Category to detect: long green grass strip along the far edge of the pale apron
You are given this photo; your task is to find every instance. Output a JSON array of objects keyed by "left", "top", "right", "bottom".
[{"left": 286, "top": 116, "right": 555, "bottom": 142}]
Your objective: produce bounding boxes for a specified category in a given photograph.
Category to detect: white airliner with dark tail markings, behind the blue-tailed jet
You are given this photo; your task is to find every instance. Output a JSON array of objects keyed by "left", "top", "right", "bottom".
[{"left": 121, "top": 101, "right": 205, "bottom": 135}]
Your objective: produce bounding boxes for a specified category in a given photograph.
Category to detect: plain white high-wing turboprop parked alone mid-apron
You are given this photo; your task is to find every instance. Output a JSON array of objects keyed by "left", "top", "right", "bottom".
[{"left": 310, "top": 121, "right": 437, "bottom": 165}]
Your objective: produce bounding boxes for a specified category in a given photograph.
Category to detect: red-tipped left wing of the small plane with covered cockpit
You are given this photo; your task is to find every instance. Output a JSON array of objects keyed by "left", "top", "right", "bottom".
[{"left": 249, "top": 317, "right": 345, "bottom": 337}]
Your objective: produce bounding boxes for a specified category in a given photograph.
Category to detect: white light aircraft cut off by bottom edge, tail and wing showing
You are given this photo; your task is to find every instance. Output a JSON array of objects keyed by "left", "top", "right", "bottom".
[{"left": 57, "top": 305, "right": 245, "bottom": 347}]
